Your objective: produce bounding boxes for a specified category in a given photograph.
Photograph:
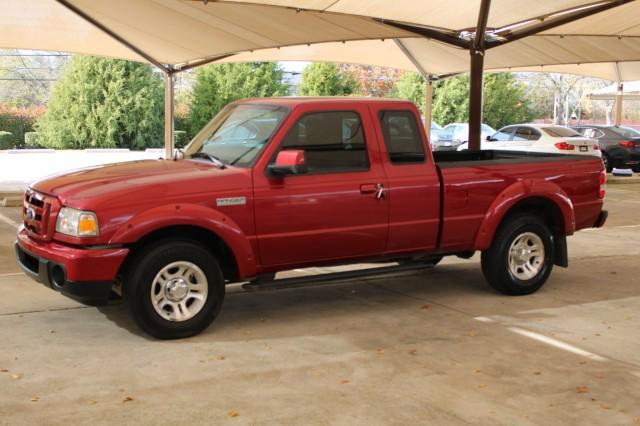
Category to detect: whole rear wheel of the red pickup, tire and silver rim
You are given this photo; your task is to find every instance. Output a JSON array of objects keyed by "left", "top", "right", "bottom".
[{"left": 482, "top": 214, "right": 553, "bottom": 295}]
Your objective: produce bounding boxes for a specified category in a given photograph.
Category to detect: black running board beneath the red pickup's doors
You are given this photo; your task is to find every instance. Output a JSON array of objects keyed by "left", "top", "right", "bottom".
[{"left": 242, "top": 263, "right": 434, "bottom": 291}]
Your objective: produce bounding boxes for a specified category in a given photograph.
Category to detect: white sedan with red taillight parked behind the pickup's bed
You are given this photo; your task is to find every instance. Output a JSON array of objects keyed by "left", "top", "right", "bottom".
[{"left": 458, "top": 124, "right": 602, "bottom": 157}]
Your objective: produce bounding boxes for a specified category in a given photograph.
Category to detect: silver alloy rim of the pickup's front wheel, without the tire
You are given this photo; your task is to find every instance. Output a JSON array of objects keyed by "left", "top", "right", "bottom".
[{"left": 151, "top": 261, "right": 209, "bottom": 322}]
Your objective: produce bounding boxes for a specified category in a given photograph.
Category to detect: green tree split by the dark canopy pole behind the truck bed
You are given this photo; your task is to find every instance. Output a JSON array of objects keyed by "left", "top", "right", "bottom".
[{"left": 433, "top": 73, "right": 534, "bottom": 128}]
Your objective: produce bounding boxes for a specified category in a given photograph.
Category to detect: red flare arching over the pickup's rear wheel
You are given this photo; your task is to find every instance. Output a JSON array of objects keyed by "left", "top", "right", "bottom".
[{"left": 474, "top": 179, "right": 576, "bottom": 250}]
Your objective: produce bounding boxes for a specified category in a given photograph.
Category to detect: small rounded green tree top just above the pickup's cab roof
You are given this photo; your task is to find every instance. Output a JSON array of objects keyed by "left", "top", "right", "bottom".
[{"left": 298, "top": 62, "right": 360, "bottom": 96}]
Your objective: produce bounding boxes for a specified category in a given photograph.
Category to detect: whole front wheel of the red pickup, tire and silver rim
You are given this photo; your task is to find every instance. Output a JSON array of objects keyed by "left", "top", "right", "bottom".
[{"left": 124, "top": 241, "right": 224, "bottom": 339}]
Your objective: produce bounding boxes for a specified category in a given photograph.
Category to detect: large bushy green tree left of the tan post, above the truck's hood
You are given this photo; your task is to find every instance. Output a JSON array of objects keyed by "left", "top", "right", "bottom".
[{"left": 36, "top": 56, "right": 163, "bottom": 149}]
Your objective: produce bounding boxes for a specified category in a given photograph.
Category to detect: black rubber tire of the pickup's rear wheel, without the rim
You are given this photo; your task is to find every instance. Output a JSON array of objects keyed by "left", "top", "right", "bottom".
[{"left": 482, "top": 214, "right": 554, "bottom": 296}]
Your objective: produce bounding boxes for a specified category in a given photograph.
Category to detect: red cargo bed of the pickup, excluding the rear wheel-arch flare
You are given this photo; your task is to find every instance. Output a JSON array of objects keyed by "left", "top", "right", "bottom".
[{"left": 433, "top": 150, "right": 602, "bottom": 252}]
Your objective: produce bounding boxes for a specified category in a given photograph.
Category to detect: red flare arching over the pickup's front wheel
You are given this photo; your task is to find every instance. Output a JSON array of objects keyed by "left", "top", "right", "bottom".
[{"left": 109, "top": 204, "right": 256, "bottom": 277}]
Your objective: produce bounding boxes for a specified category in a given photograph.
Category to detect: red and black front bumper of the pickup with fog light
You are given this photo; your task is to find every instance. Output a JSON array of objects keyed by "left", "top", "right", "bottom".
[{"left": 15, "top": 230, "right": 129, "bottom": 305}]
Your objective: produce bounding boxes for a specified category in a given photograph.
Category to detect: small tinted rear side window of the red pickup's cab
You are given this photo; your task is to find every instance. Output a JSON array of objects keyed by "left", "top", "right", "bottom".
[{"left": 379, "top": 111, "right": 424, "bottom": 164}]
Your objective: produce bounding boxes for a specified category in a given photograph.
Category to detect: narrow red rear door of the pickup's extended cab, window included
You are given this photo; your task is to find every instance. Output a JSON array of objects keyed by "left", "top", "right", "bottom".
[{"left": 372, "top": 104, "right": 440, "bottom": 253}]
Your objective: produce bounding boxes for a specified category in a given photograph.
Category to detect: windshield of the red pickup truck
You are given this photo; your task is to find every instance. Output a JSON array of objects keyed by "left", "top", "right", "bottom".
[{"left": 185, "top": 104, "right": 289, "bottom": 167}]
